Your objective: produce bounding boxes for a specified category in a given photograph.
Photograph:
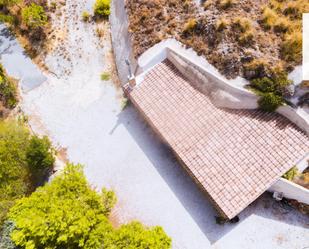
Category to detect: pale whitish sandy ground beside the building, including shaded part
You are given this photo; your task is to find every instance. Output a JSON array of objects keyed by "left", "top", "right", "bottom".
[{"left": 1, "top": 0, "right": 309, "bottom": 249}]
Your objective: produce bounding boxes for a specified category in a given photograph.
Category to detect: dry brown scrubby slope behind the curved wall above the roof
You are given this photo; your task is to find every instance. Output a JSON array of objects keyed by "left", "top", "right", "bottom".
[{"left": 127, "top": 0, "right": 309, "bottom": 78}]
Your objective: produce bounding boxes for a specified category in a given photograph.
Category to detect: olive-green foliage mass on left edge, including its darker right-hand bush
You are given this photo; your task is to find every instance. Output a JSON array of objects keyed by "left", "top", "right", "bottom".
[{"left": 0, "top": 121, "right": 54, "bottom": 227}]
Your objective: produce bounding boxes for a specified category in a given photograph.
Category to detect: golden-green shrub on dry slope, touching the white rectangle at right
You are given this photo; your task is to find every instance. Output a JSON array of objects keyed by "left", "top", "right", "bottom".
[{"left": 280, "top": 31, "right": 303, "bottom": 63}]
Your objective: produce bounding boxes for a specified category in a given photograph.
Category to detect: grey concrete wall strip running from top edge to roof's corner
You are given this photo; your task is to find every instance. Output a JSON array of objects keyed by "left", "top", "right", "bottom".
[{"left": 110, "top": 0, "right": 137, "bottom": 85}]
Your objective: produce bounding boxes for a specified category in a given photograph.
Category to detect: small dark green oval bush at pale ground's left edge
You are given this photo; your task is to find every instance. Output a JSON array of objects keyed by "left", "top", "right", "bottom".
[{"left": 26, "top": 136, "right": 55, "bottom": 186}]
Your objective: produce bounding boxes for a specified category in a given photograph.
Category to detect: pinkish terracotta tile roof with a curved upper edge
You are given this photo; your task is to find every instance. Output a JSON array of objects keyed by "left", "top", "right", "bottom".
[{"left": 125, "top": 61, "right": 309, "bottom": 218}]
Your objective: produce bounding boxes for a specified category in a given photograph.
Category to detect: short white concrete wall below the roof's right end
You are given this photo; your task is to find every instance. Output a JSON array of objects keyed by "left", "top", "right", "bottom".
[{"left": 269, "top": 178, "right": 309, "bottom": 205}]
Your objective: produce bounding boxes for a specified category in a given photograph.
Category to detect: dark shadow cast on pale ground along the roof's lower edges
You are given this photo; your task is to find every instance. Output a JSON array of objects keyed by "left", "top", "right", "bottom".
[{"left": 111, "top": 105, "right": 309, "bottom": 243}]
